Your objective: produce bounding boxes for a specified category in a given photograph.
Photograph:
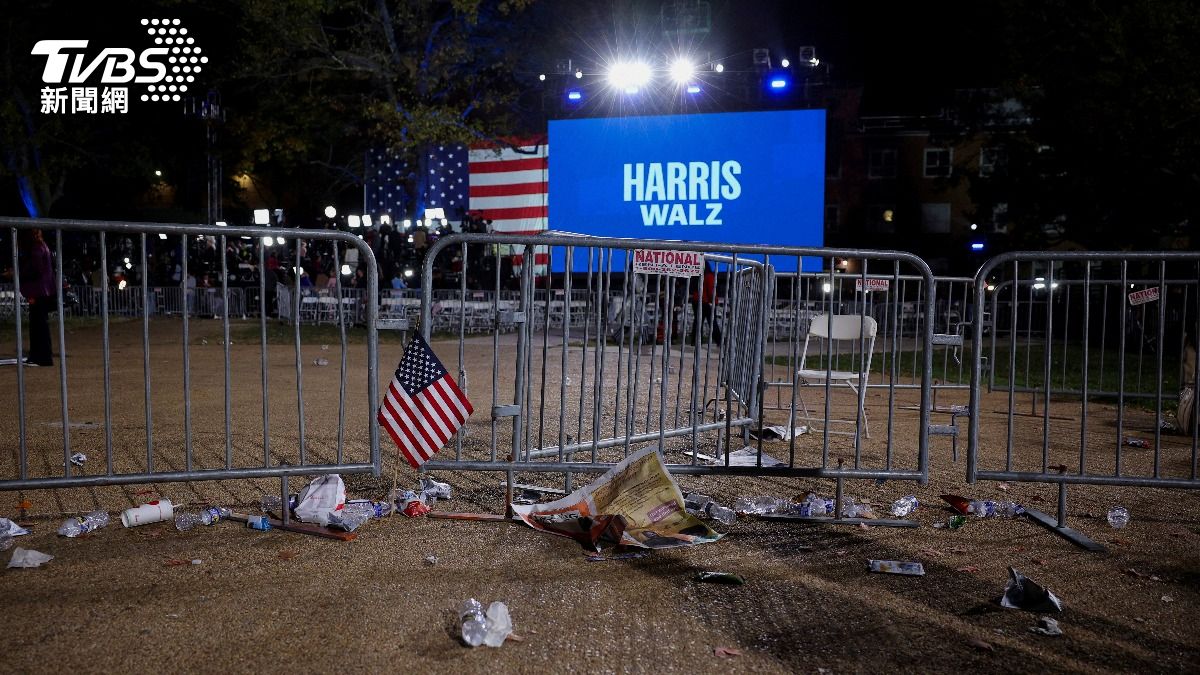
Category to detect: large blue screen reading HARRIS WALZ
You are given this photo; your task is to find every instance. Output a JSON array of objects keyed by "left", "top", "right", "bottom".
[{"left": 550, "top": 110, "right": 826, "bottom": 271}]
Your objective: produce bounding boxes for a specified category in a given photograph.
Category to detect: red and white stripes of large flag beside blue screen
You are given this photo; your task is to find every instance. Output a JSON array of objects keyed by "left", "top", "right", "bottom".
[{"left": 468, "top": 138, "right": 550, "bottom": 275}]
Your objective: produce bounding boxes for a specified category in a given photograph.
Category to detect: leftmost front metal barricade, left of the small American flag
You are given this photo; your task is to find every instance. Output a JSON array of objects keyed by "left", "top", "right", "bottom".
[{"left": 0, "top": 217, "right": 380, "bottom": 511}]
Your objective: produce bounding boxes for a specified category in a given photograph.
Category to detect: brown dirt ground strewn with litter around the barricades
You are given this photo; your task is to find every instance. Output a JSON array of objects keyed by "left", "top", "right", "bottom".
[{"left": 0, "top": 321, "right": 1200, "bottom": 673}]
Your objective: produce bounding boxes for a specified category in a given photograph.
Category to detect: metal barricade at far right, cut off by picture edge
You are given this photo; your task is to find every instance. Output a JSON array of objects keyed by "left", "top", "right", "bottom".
[{"left": 967, "top": 252, "right": 1200, "bottom": 550}]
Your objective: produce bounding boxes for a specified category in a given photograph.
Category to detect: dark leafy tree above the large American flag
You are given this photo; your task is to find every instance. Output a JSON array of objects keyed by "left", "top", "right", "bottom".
[{"left": 224, "top": 0, "right": 542, "bottom": 216}]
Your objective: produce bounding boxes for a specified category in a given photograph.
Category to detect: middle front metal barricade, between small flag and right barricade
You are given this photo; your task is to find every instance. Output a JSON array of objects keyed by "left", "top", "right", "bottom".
[{"left": 421, "top": 234, "right": 935, "bottom": 525}]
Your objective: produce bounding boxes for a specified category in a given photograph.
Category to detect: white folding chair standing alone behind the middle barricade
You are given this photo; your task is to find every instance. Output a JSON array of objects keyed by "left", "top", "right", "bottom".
[{"left": 796, "top": 315, "right": 878, "bottom": 438}]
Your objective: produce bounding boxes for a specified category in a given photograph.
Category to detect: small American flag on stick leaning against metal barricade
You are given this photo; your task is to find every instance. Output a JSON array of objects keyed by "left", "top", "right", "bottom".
[{"left": 378, "top": 335, "right": 475, "bottom": 468}]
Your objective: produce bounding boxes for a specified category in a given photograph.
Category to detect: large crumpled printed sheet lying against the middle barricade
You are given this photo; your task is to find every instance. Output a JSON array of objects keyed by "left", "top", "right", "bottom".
[{"left": 512, "top": 446, "right": 722, "bottom": 550}]
